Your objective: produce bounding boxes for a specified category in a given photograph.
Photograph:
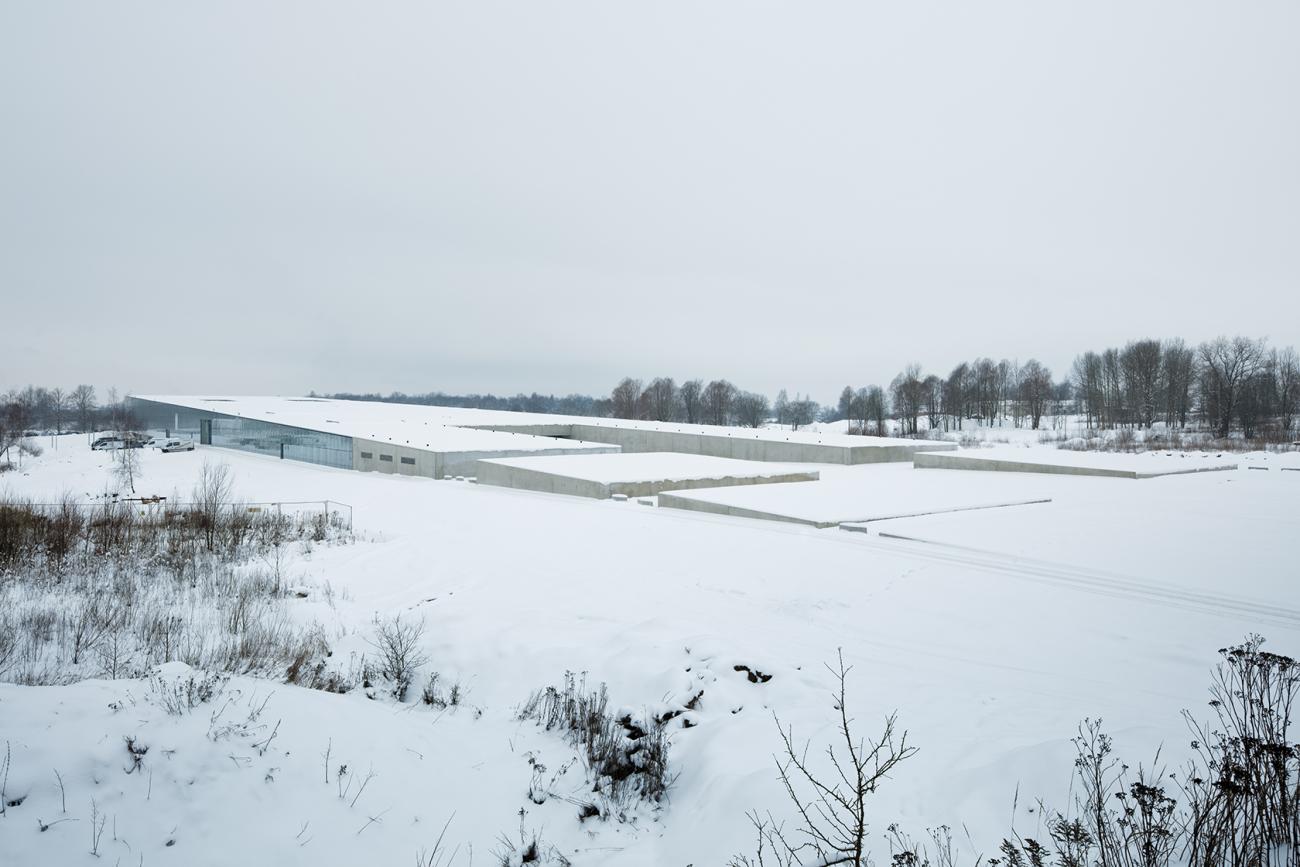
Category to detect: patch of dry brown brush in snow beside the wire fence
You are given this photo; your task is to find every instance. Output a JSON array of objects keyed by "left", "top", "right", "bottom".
[{"left": 0, "top": 498, "right": 342, "bottom": 685}]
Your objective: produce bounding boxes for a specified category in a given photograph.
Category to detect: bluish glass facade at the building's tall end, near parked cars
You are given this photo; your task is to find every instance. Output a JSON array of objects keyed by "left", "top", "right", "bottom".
[{"left": 129, "top": 398, "right": 352, "bottom": 469}]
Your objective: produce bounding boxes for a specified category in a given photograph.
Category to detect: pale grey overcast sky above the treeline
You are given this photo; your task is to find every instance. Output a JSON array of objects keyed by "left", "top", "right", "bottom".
[{"left": 0, "top": 0, "right": 1300, "bottom": 400}]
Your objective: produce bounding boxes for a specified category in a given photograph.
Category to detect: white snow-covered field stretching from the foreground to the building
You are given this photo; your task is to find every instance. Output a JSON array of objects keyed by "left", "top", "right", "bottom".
[{"left": 0, "top": 437, "right": 1300, "bottom": 866}]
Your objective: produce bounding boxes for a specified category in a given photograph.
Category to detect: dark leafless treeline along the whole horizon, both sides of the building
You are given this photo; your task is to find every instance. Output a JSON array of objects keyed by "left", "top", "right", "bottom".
[{"left": 0, "top": 337, "right": 1300, "bottom": 451}]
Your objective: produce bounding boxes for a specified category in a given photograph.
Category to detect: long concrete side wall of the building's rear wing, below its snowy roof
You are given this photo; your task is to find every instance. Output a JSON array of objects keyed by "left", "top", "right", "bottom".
[{"left": 462, "top": 422, "right": 957, "bottom": 464}]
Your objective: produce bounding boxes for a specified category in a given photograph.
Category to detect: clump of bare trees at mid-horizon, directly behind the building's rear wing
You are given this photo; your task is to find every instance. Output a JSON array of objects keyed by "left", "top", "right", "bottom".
[{"left": 610, "top": 377, "right": 820, "bottom": 429}]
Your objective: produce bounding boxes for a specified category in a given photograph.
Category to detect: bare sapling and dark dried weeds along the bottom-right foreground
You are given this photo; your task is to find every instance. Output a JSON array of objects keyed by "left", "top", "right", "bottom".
[{"left": 731, "top": 636, "right": 1300, "bottom": 867}]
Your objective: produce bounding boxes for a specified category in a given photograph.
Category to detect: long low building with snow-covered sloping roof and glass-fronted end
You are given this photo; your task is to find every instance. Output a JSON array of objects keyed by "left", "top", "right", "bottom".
[{"left": 127, "top": 395, "right": 956, "bottom": 478}]
